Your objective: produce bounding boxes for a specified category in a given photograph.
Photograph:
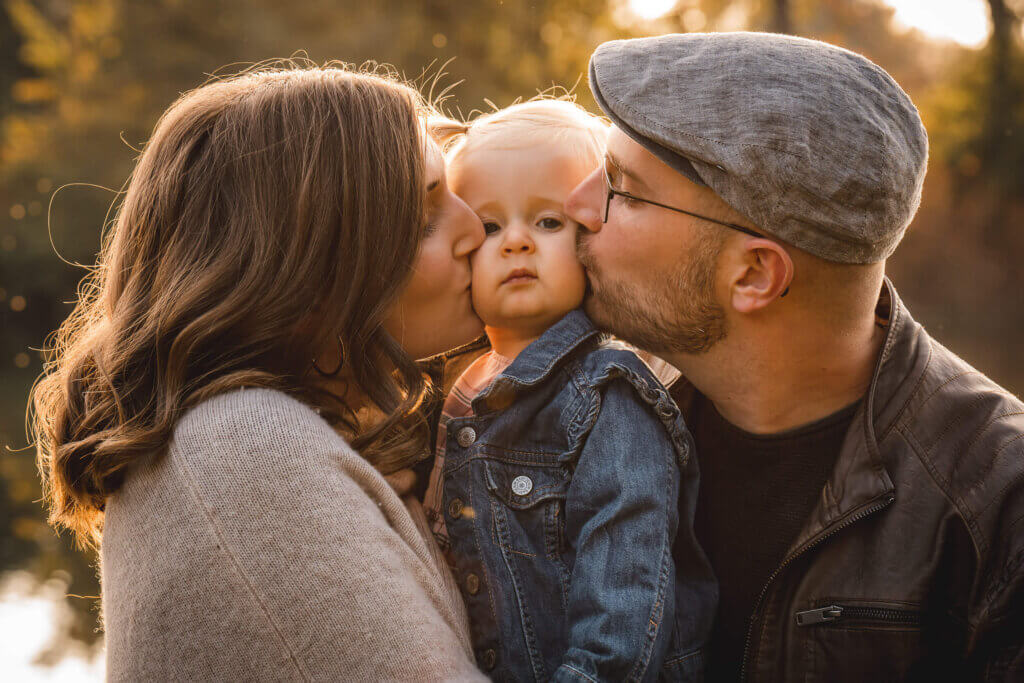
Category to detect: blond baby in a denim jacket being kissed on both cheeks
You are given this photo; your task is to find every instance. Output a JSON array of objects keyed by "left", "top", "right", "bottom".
[{"left": 425, "top": 100, "right": 717, "bottom": 681}]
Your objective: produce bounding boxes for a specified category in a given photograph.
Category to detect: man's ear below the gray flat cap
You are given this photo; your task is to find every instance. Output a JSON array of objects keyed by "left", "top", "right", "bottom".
[{"left": 729, "top": 238, "right": 794, "bottom": 313}]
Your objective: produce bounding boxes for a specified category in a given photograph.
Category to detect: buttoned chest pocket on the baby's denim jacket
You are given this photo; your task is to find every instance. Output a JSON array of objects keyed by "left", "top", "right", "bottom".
[{"left": 484, "top": 460, "right": 569, "bottom": 561}]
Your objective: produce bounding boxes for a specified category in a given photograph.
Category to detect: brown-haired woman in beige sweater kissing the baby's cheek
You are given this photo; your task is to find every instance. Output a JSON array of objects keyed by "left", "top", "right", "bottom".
[{"left": 34, "top": 62, "right": 483, "bottom": 680}]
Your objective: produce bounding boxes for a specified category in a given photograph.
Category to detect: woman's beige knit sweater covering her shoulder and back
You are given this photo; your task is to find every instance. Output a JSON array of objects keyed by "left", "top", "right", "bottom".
[{"left": 100, "top": 389, "right": 483, "bottom": 681}]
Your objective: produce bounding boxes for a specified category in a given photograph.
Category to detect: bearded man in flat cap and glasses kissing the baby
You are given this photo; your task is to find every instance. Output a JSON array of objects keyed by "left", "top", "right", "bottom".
[{"left": 567, "top": 34, "right": 1024, "bottom": 681}]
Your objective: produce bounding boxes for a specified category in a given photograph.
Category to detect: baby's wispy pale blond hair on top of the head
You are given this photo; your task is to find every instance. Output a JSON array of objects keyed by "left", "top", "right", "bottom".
[{"left": 429, "top": 97, "right": 608, "bottom": 172}]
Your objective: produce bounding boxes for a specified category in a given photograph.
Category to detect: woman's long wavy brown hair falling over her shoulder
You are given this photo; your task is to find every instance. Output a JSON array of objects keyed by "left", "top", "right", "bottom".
[{"left": 30, "top": 62, "right": 436, "bottom": 546}]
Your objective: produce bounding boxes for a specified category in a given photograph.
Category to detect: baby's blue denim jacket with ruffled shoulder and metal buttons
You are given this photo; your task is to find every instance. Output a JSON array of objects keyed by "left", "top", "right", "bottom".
[{"left": 442, "top": 310, "right": 718, "bottom": 681}]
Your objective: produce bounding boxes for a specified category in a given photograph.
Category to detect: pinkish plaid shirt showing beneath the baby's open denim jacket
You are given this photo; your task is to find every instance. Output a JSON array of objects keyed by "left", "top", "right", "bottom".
[{"left": 423, "top": 351, "right": 512, "bottom": 554}]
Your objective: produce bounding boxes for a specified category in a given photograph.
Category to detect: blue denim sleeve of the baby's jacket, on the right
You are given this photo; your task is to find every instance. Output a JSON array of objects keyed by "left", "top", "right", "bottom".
[{"left": 553, "top": 378, "right": 679, "bottom": 681}]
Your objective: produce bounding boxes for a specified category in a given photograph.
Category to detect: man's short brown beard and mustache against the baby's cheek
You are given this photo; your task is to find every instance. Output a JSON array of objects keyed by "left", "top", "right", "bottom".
[{"left": 577, "top": 230, "right": 726, "bottom": 354}]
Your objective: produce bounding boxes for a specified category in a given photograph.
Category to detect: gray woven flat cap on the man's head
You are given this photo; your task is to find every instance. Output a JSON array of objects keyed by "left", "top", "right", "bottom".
[{"left": 590, "top": 33, "right": 928, "bottom": 263}]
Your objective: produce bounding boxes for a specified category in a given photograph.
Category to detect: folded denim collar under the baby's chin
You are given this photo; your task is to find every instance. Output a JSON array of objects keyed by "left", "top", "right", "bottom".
[{"left": 473, "top": 308, "right": 600, "bottom": 415}]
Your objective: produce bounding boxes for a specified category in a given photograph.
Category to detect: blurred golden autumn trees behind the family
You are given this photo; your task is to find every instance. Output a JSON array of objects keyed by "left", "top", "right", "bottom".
[{"left": 0, "top": 0, "right": 1024, "bottom": 661}]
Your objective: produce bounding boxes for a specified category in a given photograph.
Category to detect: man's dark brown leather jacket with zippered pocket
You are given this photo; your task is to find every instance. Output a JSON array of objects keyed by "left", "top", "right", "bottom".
[{"left": 673, "top": 280, "right": 1024, "bottom": 683}]
